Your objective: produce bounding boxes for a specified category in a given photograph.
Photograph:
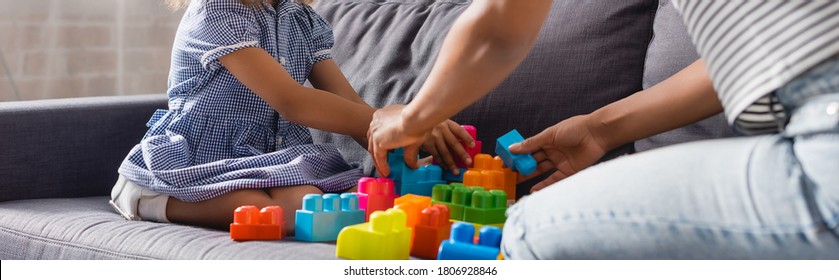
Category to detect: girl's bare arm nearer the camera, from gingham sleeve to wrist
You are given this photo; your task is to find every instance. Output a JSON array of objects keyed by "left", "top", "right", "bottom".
[{"left": 219, "top": 48, "right": 374, "bottom": 138}]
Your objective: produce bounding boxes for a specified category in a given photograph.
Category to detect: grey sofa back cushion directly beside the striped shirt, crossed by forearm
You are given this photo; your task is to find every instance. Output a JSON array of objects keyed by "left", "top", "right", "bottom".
[{"left": 635, "top": 0, "right": 734, "bottom": 152}]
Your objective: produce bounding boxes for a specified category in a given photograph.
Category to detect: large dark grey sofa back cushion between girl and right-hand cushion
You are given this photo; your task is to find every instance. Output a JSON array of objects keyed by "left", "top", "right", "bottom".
[{"left": 313, "top": 0, "right": 657, "bottom": 183}]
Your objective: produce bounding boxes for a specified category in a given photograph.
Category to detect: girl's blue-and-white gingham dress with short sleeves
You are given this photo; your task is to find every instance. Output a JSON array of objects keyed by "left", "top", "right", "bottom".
[{"left": 119, "top": 0, "right": 362, "bottom": 202}]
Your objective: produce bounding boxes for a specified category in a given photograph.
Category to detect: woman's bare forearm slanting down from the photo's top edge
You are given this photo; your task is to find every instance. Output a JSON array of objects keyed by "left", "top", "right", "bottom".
[{"left": 403, "top": 0, "right": 552, "bottom": 135}]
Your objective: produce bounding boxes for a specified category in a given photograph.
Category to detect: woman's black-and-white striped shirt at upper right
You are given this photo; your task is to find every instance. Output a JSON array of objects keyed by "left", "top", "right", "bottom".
[{"left": 673, "top": 0, "right": 839, "bottom": 134}]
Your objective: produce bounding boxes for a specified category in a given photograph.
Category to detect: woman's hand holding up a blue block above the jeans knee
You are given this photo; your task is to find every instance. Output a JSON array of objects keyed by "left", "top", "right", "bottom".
[{"left": 510, "top": 115, "right": 608, "bottom": 192}]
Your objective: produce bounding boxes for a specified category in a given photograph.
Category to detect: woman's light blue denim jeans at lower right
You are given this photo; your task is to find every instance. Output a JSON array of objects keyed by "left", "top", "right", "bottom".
[{"left": 501, "top": 60, "right": 839, "bottom": 259}]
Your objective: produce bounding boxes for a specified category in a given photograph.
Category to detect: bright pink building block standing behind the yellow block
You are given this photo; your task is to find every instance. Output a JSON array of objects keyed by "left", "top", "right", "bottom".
[{"left": 355, "top": 177, "right": 396, "bottom": 221}]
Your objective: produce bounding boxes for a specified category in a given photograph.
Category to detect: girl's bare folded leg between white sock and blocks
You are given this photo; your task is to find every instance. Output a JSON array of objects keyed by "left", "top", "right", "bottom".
[{"left": 166, "top": 185, "right": 322, "bottom": 234}]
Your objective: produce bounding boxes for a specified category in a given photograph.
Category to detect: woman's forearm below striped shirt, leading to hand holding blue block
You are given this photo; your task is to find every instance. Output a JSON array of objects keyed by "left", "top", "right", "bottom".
[{"left": 589, "top": 60, "right": 723, "bottom": 149}]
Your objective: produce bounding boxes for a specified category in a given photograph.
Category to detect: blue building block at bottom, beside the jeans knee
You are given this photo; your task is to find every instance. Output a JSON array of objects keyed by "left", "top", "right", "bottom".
[{"left": 437, "top": 222, "right": 501, "bottom": 260}]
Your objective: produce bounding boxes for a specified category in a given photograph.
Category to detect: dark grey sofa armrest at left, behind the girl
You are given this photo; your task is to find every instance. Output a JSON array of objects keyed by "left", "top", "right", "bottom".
[{"left": 0, "top": 94, "right": 167, "bottom": 201}]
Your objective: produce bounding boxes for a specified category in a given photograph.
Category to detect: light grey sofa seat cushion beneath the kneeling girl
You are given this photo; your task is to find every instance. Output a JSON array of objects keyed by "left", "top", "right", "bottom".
[{"left": 0, "top": 196, "right": 337, "bottom": 260}]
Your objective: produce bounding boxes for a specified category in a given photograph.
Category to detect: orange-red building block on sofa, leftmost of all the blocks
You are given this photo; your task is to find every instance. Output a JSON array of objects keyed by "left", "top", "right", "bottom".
[{"left": 230, "top": 205, "right": 285, "bottom": 241}]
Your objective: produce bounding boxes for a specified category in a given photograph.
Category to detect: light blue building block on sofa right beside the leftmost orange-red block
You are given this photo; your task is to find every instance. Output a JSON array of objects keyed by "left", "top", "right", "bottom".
[{"left": 294, "top": 193, "right": 365, "bottom": 242}]
